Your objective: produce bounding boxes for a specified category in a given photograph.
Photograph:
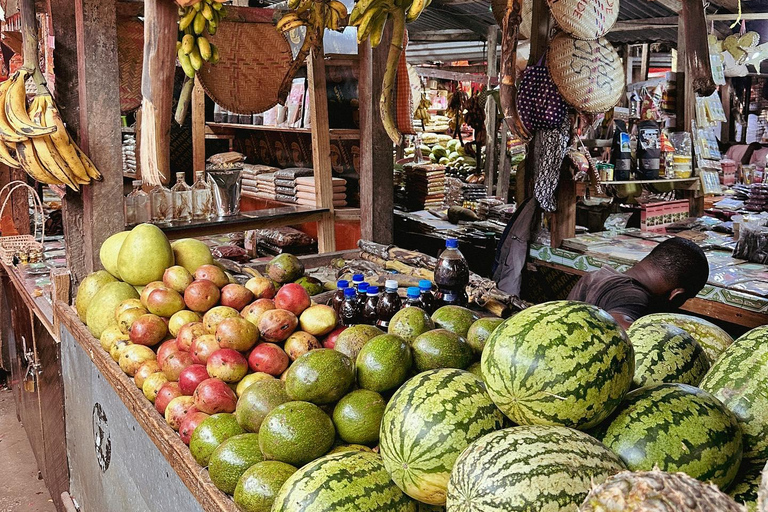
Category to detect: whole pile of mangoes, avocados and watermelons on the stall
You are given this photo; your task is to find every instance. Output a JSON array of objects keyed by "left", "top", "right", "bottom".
[{"left": 76, "top": 225, "right": 768, "bottom": 512}]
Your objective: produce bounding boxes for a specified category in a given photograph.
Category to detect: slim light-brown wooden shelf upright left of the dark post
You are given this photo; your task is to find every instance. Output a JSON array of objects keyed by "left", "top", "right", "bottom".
[{"left": 307, "top": 47, "right": 334, "bottom": 253}]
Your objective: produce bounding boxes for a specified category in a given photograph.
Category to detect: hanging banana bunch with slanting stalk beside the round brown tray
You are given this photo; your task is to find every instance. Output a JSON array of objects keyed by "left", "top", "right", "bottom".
[{"left": 276, "top": 0, "right": 347, "bottom": 105}]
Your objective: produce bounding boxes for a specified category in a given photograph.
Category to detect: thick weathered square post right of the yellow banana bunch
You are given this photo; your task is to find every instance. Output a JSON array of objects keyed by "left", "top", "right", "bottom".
[{"left": 71, "top": 0, "right": 124, "bottom": 283}]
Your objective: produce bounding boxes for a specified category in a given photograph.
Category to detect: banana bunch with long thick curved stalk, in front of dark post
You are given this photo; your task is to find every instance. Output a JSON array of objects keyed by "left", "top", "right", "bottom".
[{"left": 349, "top": 0, "right": 431, "bottom": 145}]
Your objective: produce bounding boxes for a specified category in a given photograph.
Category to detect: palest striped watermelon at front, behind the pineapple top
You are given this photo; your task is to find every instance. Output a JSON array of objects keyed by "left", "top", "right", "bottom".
[{"left": 446, "top": 425, "right": 626, "bottom": 512}]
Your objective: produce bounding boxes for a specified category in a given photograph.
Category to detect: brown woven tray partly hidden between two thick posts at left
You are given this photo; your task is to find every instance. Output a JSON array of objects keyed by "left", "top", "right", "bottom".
[{"left": 117, "top": 18, "right": 144, "bottom": 113}]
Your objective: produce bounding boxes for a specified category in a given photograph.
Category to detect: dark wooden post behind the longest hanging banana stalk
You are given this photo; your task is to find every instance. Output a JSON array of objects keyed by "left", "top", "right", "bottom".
[{"left": 358, "top": 32, "right": 394, "bottom": 245}]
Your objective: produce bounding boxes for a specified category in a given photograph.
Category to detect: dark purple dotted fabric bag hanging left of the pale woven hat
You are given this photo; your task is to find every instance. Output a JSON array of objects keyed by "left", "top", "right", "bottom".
[{"left": 517, "top": 57, "right": 568, "bottom": 131}]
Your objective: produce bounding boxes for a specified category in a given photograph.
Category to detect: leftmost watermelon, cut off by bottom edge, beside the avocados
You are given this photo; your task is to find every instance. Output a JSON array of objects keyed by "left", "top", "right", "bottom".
[{"left": 272, "top": 451, "right": 416, "bottom": 512}]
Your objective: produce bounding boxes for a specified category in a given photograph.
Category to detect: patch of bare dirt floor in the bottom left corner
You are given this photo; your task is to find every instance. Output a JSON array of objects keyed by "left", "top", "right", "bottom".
[{"left": 0, "top": 388, "right": 56, "bottom": 512}]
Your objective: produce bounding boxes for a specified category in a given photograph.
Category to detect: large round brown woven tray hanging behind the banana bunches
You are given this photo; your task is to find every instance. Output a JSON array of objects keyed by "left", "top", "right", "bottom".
[{"left": 197, "top": 21, "right": 291, "bottom": 114}]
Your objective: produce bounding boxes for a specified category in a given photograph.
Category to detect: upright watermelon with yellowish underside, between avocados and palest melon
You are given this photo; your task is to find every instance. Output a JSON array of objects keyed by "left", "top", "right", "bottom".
[{"left": 379, "top": 368, "right": 504, "bottom": 505}]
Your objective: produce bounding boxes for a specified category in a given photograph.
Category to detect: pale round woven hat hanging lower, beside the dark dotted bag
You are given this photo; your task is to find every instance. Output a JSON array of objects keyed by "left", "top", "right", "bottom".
[{"left": 547, "top": 32, "right": 625, "bottom": 114}]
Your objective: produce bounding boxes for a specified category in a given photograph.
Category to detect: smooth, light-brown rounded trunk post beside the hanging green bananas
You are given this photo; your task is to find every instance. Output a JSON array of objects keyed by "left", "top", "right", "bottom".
[{"left": 139, "top": 0, "right": 179, "bottom": 185}]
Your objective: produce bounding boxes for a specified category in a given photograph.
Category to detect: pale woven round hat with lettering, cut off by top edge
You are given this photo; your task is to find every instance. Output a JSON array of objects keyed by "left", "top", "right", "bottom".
[{"left": 547, "top": 0, "right": 619, "bottom": 41}]
